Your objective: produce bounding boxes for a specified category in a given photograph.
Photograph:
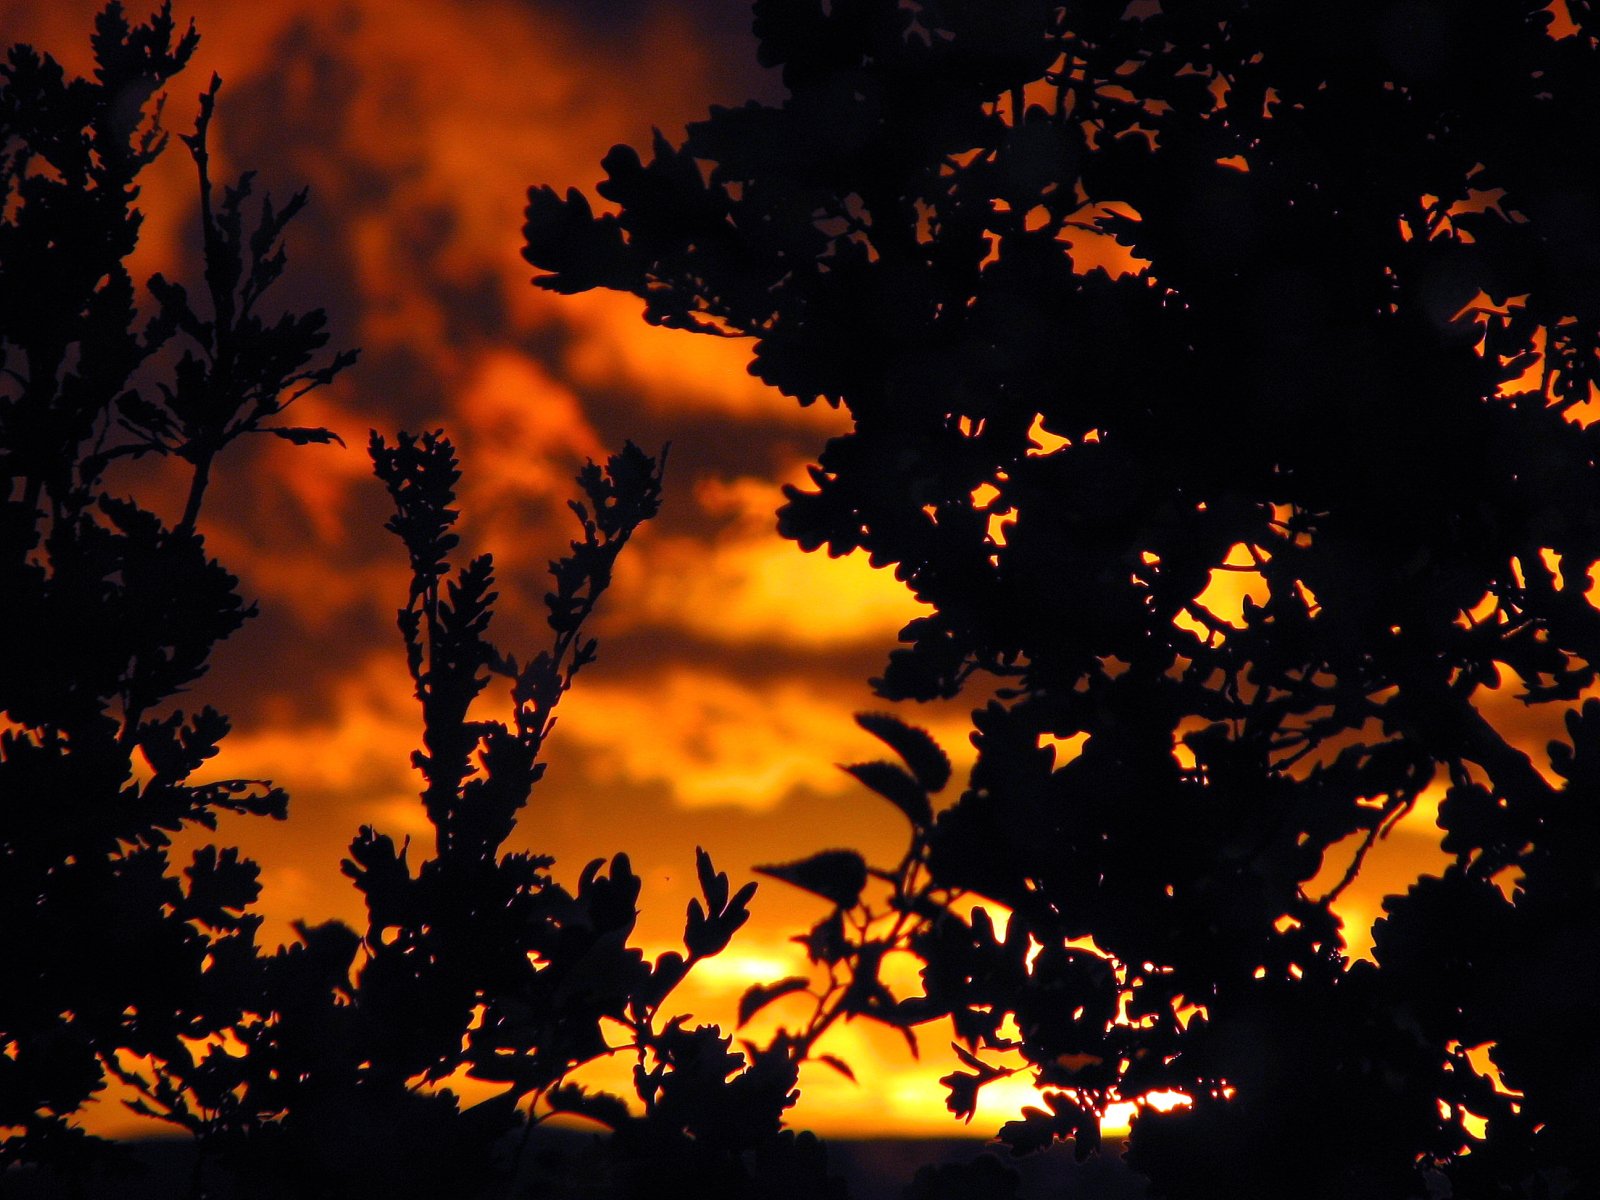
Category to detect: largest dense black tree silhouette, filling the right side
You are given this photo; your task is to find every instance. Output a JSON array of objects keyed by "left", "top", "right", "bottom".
[{"left": 525, "top": 0, "right": 1600, "bottom": 1198}]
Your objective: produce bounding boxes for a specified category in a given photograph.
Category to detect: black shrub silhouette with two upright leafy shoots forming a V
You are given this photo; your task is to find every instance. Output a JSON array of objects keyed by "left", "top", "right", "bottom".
[{"left": 126, "top": 434, "right": 822, "bottom": 1197}]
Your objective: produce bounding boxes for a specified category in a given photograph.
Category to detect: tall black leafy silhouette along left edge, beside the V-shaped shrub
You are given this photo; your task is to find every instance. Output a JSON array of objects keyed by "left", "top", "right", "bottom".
[{"left": 0, "top": 3, "right": 354, "bottom": 1166}]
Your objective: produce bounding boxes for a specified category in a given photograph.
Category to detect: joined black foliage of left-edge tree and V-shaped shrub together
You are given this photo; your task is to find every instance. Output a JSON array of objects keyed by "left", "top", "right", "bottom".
[{"left": 0, "top": 11, "right": 842, "bottom": 1200}]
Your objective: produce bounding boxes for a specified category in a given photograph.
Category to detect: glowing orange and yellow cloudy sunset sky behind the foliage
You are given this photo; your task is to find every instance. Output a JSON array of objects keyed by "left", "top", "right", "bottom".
[{"left": 0, "top": 0, "right": 1544, "bottom": 1134}]
